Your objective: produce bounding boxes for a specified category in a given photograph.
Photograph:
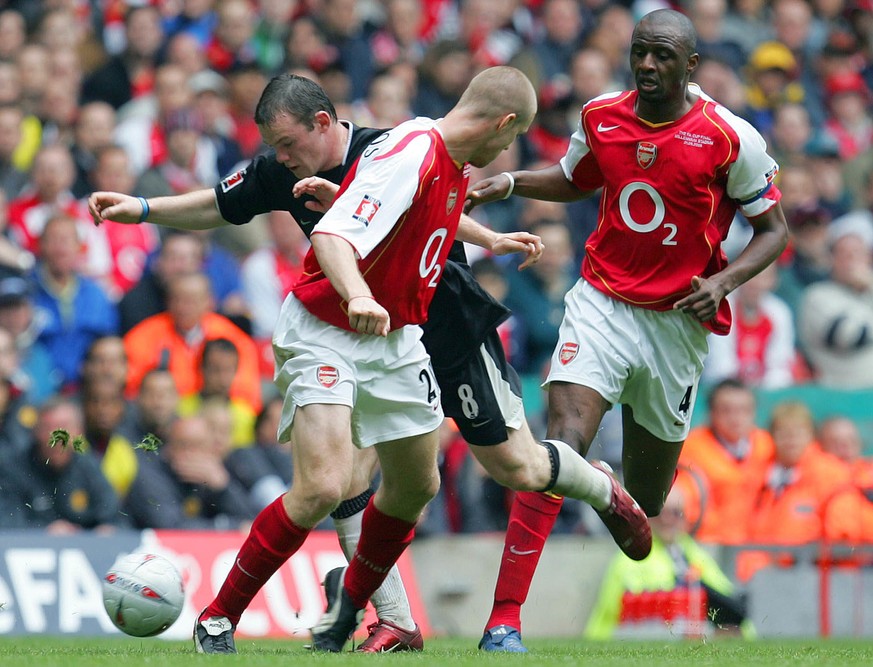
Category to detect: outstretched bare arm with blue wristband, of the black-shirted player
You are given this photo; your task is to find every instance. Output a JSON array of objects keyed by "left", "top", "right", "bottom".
[{"left": 88, "top": 188, "right": 230, "bottom": 229}]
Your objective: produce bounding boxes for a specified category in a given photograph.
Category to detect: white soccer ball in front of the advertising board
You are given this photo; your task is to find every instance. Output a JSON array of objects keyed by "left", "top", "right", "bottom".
[{"left": 103, "top": 553, "right": 185, "bottom": 637}]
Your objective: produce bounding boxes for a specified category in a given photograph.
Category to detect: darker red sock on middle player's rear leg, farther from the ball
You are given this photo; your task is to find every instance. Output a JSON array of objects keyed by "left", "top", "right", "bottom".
[{"left": 343, "top": 499, "right": 415, "bottom": 609}]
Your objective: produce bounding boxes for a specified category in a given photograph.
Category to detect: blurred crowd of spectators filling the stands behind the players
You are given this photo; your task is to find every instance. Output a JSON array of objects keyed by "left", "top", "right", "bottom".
[{"left": 0, "top": 0, "right": 873, "bottom": 588}]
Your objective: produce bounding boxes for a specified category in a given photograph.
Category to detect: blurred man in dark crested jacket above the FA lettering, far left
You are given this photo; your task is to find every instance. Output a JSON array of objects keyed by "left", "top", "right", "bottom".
[{"left": 0, "top": 399, "right": 119, "bottom": 535}]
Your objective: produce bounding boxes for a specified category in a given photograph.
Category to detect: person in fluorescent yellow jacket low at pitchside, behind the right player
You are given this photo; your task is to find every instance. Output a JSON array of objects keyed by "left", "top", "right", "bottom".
[{"left": 585, "top": 486, "right": 754, "bottom": 639}]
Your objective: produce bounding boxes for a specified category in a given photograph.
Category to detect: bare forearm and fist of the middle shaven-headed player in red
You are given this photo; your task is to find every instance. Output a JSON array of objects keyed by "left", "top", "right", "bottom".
[{"left": 310, "top": 232, "right": 391, "bottom": 336}]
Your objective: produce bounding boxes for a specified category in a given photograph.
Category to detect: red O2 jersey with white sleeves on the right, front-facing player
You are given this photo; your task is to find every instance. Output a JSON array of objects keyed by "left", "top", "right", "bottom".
[{"left": 561, "top": 84, "right": 781, "bottom": 334}]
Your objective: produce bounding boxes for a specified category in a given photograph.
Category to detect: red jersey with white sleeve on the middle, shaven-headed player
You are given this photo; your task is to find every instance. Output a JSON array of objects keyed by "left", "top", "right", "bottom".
[{"left": 293, "top": 118, "right": 469, "bottom": 330}]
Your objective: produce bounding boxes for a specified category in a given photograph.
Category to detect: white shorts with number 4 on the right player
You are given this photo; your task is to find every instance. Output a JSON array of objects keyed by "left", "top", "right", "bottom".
[{"left": 543, "top": 278, "right": 709, "bottom": 442}]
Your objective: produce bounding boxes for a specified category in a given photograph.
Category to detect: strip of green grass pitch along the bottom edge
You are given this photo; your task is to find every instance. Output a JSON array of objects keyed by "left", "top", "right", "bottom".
[{"left": 0, "top": 637, "right": 873, "bottom": 667}]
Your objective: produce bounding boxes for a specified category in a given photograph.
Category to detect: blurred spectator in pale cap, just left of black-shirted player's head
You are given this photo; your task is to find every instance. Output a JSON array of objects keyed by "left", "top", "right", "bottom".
[{"left": 188, "top": 70, "right": 243, "bottom": 176}]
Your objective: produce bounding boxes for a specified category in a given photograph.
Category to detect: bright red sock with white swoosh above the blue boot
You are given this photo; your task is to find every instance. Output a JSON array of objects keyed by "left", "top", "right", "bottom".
[{"left": 485, "top": 491, "right": 564, "bottom": 630}]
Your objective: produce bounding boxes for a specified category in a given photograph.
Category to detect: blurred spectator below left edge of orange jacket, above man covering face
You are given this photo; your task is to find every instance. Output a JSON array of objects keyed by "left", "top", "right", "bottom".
[{"left": 119, "top": 368, "right": 179, "bottom": 443}]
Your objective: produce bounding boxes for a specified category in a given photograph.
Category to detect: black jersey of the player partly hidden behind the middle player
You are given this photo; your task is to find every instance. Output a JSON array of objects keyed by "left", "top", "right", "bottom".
[{"left": 215, "top": 121, "right": 510, "bottom": 372}]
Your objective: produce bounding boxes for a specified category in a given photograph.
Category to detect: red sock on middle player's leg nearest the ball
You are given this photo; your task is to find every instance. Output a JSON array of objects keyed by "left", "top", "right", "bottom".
[{"left": 200, "top": 497, "right": 309, "bottom": 626}]
